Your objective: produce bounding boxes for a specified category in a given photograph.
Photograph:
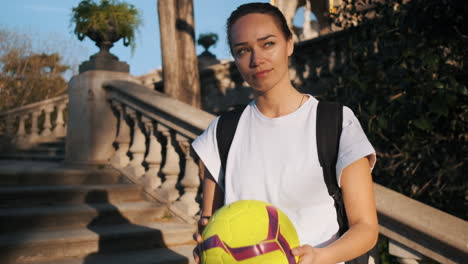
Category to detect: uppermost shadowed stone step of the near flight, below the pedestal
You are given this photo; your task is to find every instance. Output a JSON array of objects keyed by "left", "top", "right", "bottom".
[{"left": 0, "top": 167, "right": 123, "bottom": 186}]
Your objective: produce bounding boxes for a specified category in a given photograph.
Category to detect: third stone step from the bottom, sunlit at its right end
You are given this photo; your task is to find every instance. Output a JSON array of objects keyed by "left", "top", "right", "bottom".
[{"left": 0, "top": 201, "right": 171, "bottom": 232}]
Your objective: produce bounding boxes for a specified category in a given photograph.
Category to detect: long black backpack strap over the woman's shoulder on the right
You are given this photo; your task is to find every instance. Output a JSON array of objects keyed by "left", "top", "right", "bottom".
[{"left": 316, "top": 102, "right": 348, "bottom": 234}]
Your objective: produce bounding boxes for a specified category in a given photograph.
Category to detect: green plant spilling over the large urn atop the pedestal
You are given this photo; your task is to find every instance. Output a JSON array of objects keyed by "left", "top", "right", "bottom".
[{"left": 71, "top": 0, "right": 142, "bottom": 50}]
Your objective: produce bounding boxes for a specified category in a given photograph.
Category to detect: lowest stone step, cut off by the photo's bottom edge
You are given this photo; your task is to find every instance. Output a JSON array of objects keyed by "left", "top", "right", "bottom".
[{"left": 26, "top": 245, "right": 196, "bottom": 264}]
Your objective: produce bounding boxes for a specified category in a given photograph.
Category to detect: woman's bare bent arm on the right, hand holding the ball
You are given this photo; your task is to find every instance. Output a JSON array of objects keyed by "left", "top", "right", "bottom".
[{"left": 293, "top": 158, "right": 379, "bottom": 264}]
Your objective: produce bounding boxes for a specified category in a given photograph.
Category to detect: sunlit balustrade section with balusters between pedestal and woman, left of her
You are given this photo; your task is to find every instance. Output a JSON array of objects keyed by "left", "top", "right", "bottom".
[{"left": 104, "top": 81, "right": 215, "bottom": 221}]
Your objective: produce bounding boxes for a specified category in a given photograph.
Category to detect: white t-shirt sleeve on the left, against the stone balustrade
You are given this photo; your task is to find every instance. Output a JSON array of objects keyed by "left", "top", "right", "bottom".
[{"left": 192, "top": 117, "right": 222, "bottom": 187}]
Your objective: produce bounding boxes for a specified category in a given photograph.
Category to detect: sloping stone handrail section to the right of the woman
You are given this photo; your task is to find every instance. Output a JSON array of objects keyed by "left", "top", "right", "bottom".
[{"left": 375, "top": 184, "right": 468, "bottom": 263}]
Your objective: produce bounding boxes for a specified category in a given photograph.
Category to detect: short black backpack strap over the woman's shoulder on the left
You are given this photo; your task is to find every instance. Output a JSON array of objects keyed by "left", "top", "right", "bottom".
[{"left": 216, "top": 107, "right": 245, "bottom": 190}]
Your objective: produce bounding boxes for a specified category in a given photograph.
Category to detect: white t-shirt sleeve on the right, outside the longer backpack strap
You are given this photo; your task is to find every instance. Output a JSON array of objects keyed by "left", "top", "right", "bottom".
[{"left": 336, "top": 106, "right": 376, "bottom": 187}]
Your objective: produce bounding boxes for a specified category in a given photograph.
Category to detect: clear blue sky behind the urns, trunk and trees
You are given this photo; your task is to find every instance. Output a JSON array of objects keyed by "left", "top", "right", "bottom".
[{"left": 0, "top": 0, "right": 310, "bottom": 76}]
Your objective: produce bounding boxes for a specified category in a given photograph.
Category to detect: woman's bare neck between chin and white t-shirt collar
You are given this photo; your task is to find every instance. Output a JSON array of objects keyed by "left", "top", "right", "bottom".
[{"left": 255, "top": 79, "right": 308, "bottom": 118}]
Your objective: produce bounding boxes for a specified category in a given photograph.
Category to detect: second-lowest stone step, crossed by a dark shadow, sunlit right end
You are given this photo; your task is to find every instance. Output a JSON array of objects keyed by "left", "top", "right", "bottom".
[{"left": 0, "top": 223, "right": 195, "bottom": 264}]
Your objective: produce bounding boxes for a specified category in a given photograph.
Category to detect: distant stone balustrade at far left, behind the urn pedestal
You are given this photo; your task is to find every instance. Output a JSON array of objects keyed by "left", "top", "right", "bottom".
[{"left": 0, "top": 95, "right": 68, "bottom": 149}]
